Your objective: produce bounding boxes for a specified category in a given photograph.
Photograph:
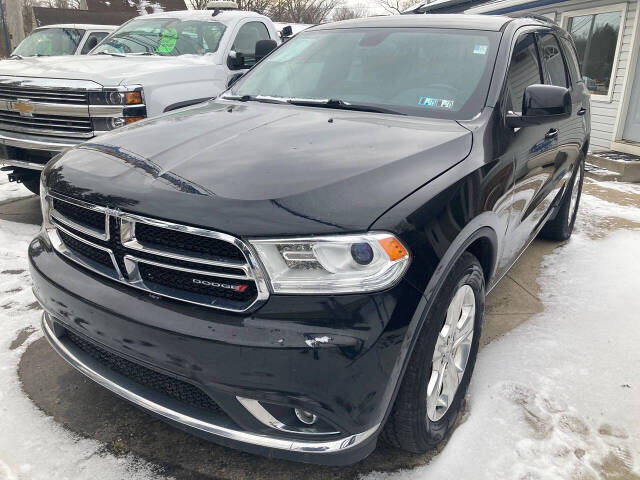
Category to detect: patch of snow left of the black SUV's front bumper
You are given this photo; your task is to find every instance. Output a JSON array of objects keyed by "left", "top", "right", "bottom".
[{"left": 0, "top": 185, "right": 168, "bottom": 480}]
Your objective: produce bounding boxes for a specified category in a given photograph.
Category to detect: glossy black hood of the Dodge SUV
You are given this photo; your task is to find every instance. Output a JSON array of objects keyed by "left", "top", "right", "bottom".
[{"left": 45, "top": 101, "right": 472, "bottom": 236}]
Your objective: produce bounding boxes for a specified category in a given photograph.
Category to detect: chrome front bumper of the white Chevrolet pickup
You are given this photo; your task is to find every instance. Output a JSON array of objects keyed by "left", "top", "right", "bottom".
[{"left": 0, "top": 130, "right": 87, "bottom": 170}]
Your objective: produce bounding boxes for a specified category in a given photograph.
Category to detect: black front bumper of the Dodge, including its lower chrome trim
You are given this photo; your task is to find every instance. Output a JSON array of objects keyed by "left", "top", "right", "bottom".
[{"left": 29, "top": 232, "right": 421, "bottom": 464}]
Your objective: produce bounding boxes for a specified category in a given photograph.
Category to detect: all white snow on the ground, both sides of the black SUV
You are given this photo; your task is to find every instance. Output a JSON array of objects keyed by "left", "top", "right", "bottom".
[{"left": 0, "top": 180, "right": 640, "bottom": 480}]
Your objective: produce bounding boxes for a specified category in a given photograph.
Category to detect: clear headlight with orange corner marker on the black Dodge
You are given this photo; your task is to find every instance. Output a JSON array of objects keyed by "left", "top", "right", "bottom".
[{"left": 250, "top": 232, "right": 409, "bottom": 294}]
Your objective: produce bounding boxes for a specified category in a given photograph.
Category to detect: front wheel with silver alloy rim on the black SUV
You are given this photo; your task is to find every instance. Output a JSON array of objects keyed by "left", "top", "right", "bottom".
[{"left": 381, "top": 253, "right": 485, "bottom": 453}]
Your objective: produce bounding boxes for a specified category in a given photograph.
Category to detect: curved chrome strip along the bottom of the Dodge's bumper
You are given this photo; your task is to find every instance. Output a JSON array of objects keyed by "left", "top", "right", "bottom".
[{"left": 42, "top": 313, "right": 379, "bottom": 455}]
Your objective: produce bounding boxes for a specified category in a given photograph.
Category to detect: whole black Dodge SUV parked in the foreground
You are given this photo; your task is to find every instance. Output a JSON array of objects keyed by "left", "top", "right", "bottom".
[{"left": 29, "top": 15, "right": 590, "bottom": 464}]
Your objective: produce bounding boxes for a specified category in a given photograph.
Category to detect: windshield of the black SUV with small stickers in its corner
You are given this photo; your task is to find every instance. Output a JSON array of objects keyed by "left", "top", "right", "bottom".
[{"left": 232, "top": 28, "right": 500, "bottom": 119}]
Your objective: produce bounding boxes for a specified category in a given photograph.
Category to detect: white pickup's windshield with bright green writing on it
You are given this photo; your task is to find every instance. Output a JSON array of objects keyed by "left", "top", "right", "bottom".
[{"left": 91, "top": 18, "right": 226, "bottom": 56}]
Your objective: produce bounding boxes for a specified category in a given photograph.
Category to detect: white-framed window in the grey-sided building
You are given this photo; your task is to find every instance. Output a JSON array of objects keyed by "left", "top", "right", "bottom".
[{"left": 565, "top": 7, "right": 624, "bottom": 98}]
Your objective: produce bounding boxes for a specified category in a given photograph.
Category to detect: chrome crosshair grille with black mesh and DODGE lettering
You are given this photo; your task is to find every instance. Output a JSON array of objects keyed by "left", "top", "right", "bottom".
[{"left": 44, "top": 192, "right": 269, "bottom": 312}]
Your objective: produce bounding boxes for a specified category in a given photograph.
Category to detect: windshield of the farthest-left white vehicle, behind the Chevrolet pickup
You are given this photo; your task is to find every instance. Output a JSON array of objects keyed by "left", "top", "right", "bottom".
[{"left": 13, "top": 28, "right": 84, "bottom": 57}]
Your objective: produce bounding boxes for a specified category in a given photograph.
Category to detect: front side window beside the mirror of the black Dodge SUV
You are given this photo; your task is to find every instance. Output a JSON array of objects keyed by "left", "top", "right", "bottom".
[{"left": 507, "top": 33, "right": 542, "bottom": 113}]
